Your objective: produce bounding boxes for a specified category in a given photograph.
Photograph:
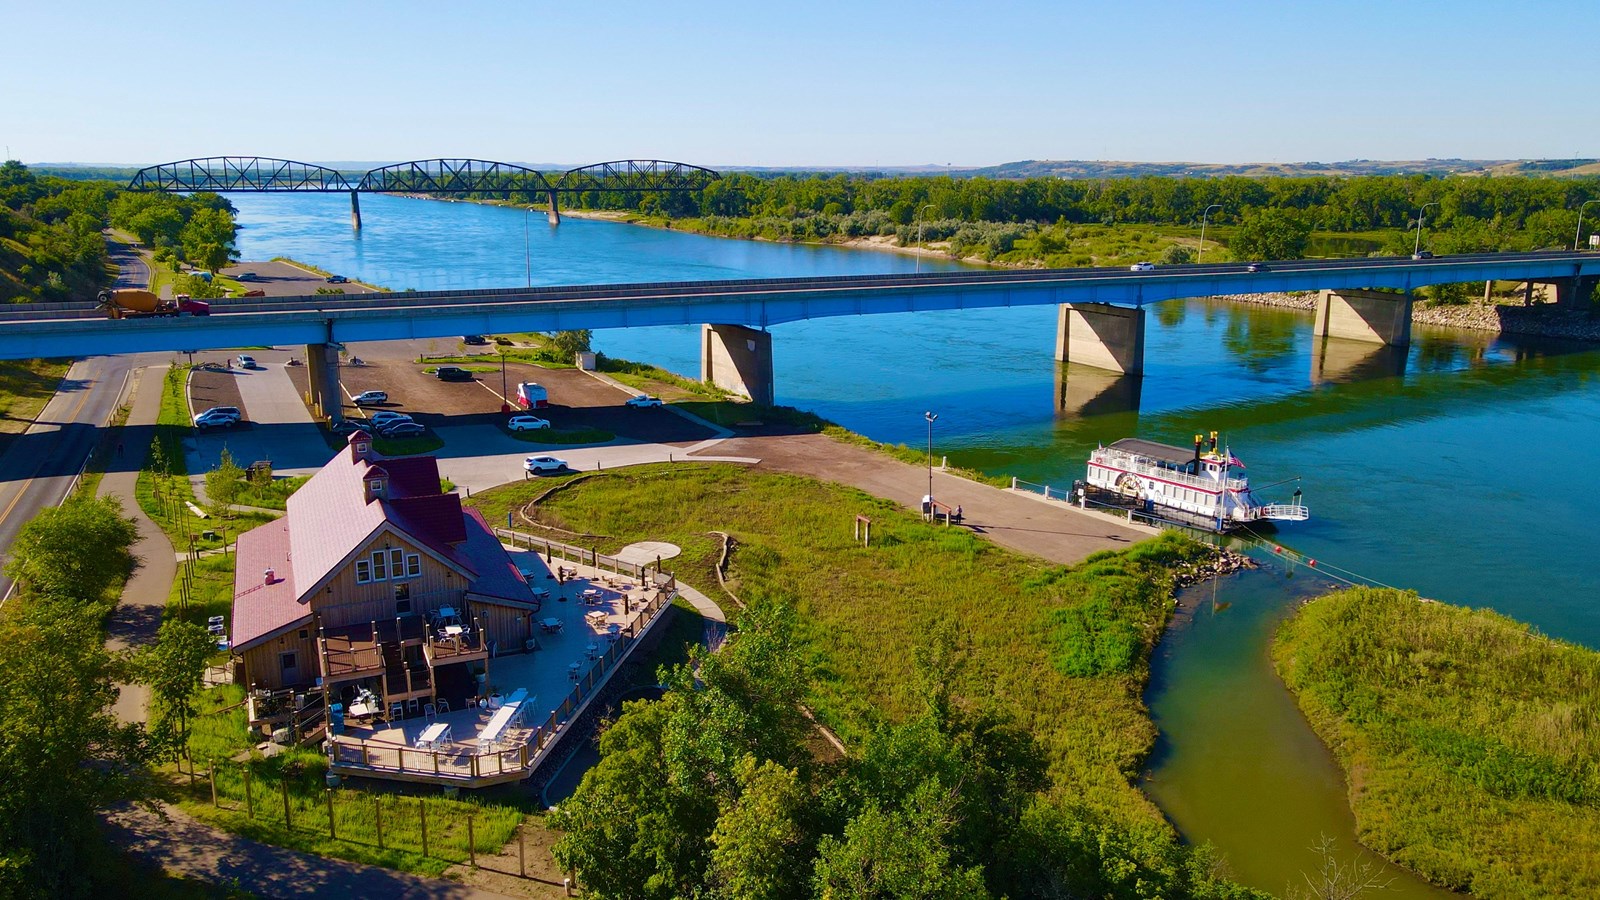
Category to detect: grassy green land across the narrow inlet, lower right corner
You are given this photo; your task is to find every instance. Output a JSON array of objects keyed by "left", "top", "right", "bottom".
[{"left": 1274, "top": 588, "right": 1600, "bottom": 898}]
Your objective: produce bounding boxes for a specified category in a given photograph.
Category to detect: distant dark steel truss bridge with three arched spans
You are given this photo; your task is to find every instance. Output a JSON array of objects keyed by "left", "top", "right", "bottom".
[{"left": 128, "top": 157, "right": 722, "bottom": 227}]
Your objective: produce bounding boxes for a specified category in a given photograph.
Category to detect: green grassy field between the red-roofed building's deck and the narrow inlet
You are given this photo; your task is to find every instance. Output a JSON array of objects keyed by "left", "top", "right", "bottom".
[{"left": 470, "top": 466, "right": 1197, "bottom": 828}]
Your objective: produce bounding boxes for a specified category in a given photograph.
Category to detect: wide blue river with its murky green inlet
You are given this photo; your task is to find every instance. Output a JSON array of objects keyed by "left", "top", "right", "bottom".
[{"left": 232, "top": 195, "right": 1600, "bottom": 897}]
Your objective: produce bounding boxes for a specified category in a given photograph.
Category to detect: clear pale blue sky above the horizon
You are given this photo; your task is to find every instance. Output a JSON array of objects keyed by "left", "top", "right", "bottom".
[{"left": 0, "top": 0, "right": 1600, "bottom": 167}]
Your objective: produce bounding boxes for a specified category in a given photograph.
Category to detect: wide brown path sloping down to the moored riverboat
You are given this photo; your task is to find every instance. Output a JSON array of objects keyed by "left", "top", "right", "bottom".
[{"left": 694, "top": 434, "right": 1155, "bottom": 564}]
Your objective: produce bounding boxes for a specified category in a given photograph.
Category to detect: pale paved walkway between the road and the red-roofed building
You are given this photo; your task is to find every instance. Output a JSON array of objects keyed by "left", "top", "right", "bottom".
[{"left": 99, "top": 365, "right": 178, "bottom": 722}]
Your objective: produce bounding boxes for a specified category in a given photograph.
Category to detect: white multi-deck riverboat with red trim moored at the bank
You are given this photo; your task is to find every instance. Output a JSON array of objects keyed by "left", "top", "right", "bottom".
[{"left": 1085, "top": 431, "right": 1310, "bottom": 532}]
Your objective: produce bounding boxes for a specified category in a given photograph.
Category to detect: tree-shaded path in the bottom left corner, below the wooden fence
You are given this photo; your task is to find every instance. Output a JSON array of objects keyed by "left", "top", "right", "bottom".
[{"left": 106, "top": 797, "right": 504, "bottom": 900}]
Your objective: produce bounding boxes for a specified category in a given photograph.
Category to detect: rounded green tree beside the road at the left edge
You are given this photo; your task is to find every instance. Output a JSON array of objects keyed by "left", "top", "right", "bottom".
[{"left": 6, "top": 496, "right": 139, "bottom": 604}]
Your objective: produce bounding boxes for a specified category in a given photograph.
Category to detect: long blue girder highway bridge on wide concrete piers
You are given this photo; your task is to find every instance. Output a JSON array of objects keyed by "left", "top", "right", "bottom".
[{"left": 0, "top": 251, "right": 1600, "bottom": 416}]
